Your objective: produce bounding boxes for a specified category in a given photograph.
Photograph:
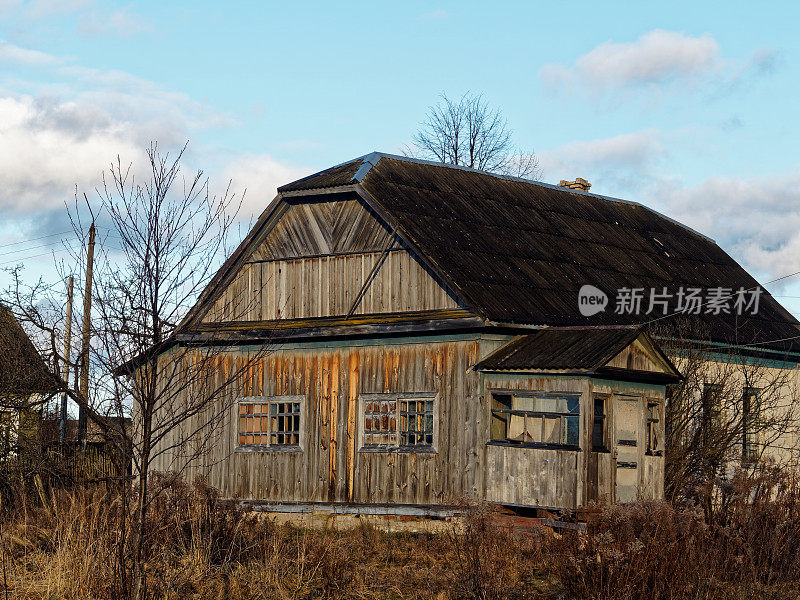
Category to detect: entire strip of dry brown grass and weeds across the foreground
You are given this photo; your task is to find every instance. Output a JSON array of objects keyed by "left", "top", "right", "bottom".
[{"left": 0, "top": 468, "right": 800, "bottom": 600}]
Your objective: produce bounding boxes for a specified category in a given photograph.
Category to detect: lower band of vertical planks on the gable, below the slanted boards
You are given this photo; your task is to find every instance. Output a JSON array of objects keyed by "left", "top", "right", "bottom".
[{"left": 203, "top": 250, "right": 459, "bottom": 323}]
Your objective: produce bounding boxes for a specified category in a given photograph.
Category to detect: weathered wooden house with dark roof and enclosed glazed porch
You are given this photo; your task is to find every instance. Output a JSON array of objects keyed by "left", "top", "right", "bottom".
[{"left": 148, "top": 153, "right": 800, "bottom": 514}]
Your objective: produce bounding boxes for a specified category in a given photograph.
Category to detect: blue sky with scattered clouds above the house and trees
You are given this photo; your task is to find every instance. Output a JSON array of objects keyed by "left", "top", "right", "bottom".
[{"left": 0, "top": 0, "right": 800, "bottom": 312}]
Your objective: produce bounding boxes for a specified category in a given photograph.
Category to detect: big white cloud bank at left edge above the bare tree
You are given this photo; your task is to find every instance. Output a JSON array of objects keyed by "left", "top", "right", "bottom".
[{"left": 0, "top": 47, "right": 233, "bottom": 219}]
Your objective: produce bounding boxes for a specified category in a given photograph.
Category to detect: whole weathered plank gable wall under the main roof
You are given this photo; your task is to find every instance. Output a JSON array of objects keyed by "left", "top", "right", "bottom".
[{"left": 203, "top": 199, "right": 459, "bottom": 323}]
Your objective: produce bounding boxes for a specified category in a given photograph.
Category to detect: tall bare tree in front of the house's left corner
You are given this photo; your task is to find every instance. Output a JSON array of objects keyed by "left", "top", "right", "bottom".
[{"left": 2, "top": 144, "right": 267, "bottom": 599}]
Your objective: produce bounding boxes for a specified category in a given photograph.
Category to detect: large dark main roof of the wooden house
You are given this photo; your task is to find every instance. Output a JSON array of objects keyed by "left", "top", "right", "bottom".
[{"left": 279, "top": 153, "right": 800, "bottom": 352}]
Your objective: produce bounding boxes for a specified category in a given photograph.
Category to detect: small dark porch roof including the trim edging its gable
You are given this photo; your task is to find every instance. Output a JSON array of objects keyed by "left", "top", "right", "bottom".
[{"left": 475, "top": 327, "right": 680, "bottom": 382}]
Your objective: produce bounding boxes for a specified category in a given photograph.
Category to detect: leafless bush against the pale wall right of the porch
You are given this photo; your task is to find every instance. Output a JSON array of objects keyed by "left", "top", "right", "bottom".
[{"left": 655, "top": 323, "right": 800, "bottom": 512}]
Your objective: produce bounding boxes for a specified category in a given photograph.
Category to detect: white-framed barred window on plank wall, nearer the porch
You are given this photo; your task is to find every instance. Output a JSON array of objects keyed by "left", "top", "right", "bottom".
[{"left": 362, "top": 394, "right": 436, "bottom": 450}]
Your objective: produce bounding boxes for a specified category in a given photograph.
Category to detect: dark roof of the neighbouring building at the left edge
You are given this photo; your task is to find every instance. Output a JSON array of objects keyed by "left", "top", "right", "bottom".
[{"left": 0, "top": 304, "right": 58, "bottom": 397}]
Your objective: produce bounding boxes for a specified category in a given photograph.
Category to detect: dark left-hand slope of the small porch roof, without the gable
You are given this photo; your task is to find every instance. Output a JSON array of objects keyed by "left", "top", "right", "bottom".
[{"left": 475, "top": 327, "right": 642, "bottom": 371}]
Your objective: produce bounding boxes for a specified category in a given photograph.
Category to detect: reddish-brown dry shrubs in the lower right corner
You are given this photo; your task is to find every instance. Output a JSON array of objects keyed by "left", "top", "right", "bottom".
[{"left": 557, "top": 471, "right": 800, "bottom": 600}]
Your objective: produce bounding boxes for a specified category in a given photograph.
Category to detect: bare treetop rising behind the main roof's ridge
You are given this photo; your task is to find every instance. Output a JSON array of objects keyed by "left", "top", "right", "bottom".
[{"left": 406, "top": 92, "right": 541, "bottom": 178}]
